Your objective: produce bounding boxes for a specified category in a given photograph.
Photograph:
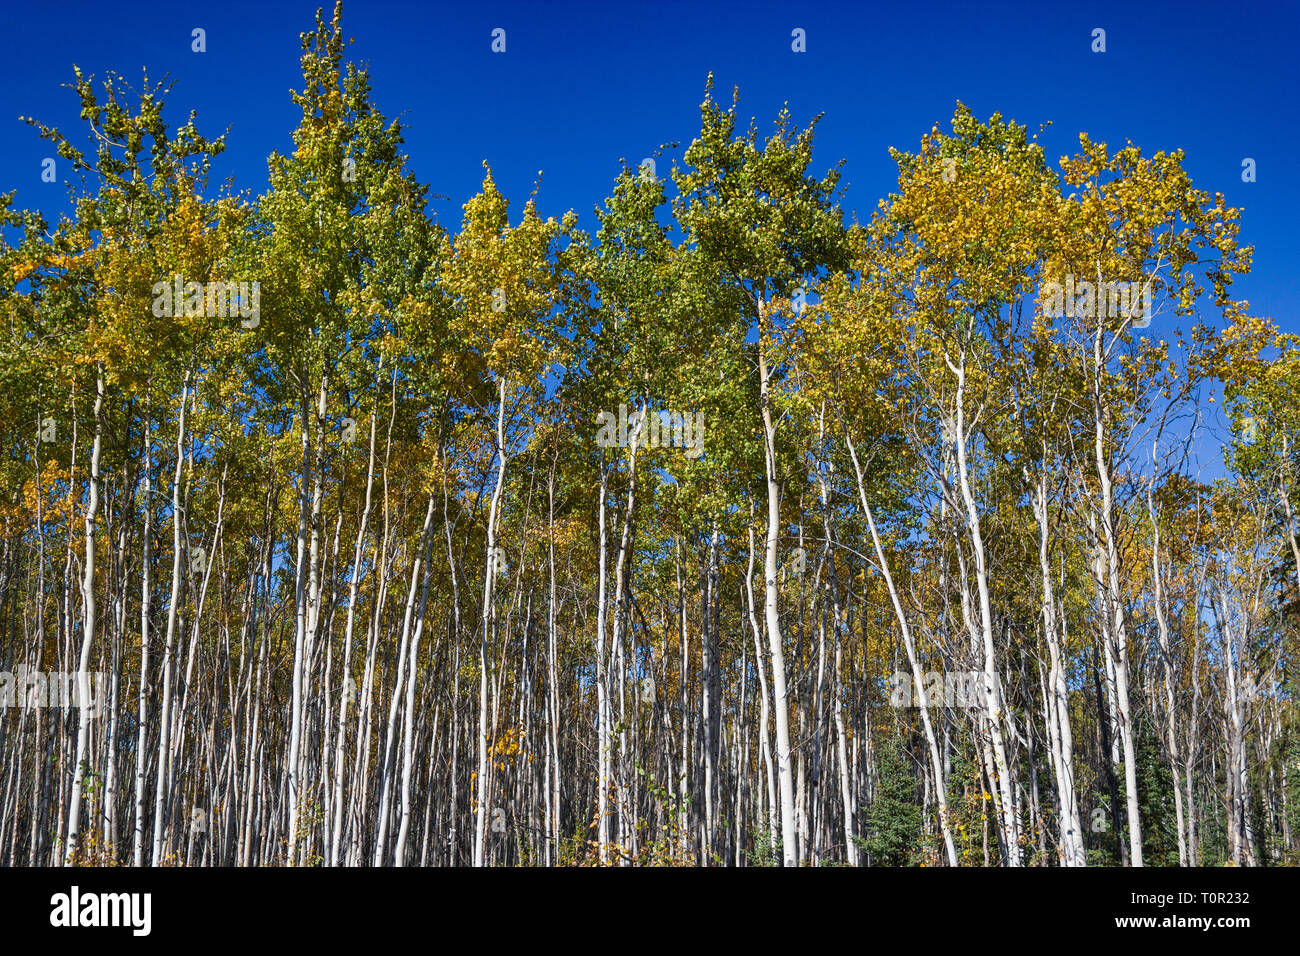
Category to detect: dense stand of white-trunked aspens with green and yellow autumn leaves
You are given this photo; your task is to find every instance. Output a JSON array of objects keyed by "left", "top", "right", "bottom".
[{"left": 0, "top": 1, "right": 1300, "bottom": 866}]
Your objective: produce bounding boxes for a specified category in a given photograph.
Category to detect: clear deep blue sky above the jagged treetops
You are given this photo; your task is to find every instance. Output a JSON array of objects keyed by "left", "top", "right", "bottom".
[{"left": 0, "top": 0, "right": 1300, "bottom": 343}]
